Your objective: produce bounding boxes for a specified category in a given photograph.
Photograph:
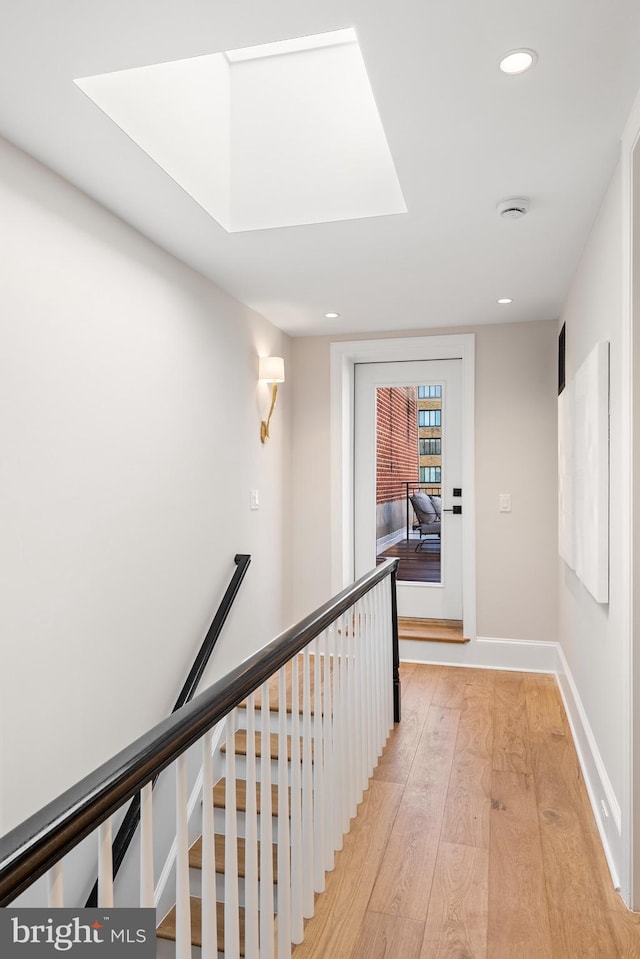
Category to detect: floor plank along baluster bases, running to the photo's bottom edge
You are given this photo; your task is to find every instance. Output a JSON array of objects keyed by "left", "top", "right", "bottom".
[{"left": 293, "top": 782, "right": 402, "bottom": 959}]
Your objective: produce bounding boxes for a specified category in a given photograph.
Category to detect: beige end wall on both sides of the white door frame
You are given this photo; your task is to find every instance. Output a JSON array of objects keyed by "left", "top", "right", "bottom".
[{"left": 293, "top": 322, "right": 557, "bottom": 642}]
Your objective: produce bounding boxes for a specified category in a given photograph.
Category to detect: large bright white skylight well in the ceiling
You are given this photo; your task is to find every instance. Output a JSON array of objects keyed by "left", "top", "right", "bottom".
[{"left": 75, "top": 29, "right": 406, "bottom": 232}]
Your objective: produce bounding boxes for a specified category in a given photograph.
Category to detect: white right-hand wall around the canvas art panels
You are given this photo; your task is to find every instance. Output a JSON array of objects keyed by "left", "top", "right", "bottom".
[{"left": 559, "top": 161, "right": 631, "bottom": 869}]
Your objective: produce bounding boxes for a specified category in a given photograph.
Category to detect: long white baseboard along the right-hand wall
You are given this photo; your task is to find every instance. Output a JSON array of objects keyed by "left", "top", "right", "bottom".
[{"left": 557, "top": 646, "right": 624, "bottom": 889}]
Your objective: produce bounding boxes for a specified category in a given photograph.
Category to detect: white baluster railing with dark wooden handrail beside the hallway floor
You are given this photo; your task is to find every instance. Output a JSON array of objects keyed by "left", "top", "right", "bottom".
[{"left": 0, "top": 560, "right": 400, "bottom": 959}]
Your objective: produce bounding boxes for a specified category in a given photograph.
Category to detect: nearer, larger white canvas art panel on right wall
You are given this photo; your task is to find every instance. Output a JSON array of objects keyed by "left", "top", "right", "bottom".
[{"left": 572, "top": 342, "right": 609, "bottom": 603}]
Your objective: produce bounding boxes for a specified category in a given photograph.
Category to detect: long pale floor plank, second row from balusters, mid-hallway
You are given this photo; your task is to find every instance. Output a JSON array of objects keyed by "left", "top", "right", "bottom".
[{"left": 370, "top": 706, "right": 460, "bottom": 921}]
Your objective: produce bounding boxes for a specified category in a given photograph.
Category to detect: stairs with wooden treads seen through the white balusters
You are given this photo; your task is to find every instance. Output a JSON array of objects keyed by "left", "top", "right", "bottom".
[{"left": 157, "top": 656, "right": 324, "bottom": 959}]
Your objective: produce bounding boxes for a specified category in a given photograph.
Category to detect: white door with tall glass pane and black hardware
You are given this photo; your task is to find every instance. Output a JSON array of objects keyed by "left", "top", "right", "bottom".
[{"left": 354, "top": 359, "right": 464, "bottom": 619}]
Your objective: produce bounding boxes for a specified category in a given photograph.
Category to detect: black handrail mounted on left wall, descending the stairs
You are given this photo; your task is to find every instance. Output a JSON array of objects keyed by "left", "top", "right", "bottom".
[{"left": 85, "top": 553, "right": 251, "bottom": 907}]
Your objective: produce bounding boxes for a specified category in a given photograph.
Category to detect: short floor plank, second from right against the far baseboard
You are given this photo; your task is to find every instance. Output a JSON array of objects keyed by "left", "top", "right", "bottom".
[{"left": 493, "top": 672, "right": 531, "bottom": 773}]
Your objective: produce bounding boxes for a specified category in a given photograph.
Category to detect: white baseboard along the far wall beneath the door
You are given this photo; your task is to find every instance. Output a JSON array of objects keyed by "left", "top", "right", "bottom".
[{"left": 400, "top": 636, "right": 558, "bottom": 673}]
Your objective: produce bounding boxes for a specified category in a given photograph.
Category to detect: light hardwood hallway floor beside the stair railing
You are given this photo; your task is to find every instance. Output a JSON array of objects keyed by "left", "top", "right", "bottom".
[{"left": 294, "top": 666, "right": 640, "bottom": 959}]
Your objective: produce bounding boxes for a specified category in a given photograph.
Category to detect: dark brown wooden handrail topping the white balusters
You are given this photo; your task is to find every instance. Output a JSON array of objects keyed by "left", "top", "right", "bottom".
[{"left": 0, "top": 559, "right": 398, "bottom": 907}]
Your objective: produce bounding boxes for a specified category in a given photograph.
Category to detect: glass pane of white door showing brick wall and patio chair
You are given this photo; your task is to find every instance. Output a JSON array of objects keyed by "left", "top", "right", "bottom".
[{"left": 376, "top": 383, "right": 443, "bottom": 583}]
